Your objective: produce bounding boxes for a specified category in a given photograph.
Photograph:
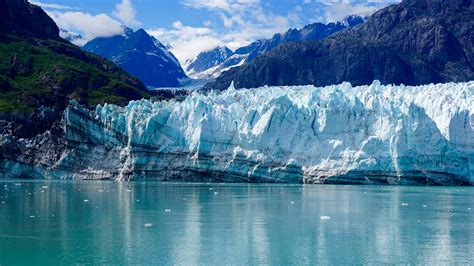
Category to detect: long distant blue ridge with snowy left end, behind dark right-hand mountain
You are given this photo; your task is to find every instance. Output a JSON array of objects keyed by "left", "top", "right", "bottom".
[{"left": 186, "top": 15, "right": 364, "bottom": 79}]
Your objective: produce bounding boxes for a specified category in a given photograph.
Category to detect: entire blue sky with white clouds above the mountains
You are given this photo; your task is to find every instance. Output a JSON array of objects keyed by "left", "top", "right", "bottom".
[{"left": 30, "top": 0, "right": 399, "bottom": 64}]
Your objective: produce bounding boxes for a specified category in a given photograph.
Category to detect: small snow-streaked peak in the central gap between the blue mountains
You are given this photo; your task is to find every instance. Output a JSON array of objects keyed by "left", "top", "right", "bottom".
[{"left": 186, "top": 46, "right": 234, "bottom": 79}]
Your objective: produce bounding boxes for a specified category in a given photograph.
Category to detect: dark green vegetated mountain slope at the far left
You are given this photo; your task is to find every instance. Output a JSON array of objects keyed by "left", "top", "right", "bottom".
[{"left": 0, "top": 0, "right": 149, "bottom": 113}]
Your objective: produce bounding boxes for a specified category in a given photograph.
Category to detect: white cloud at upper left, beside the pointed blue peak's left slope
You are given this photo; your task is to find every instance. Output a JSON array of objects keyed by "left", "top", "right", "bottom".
[{"left": 47, "top": 11, "right": 123, "bottom": 40}]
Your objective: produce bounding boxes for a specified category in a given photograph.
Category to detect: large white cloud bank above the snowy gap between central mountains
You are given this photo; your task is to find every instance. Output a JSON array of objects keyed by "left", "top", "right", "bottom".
[{"left": 157, "top": 0, "right": 299, "bottom": 63}]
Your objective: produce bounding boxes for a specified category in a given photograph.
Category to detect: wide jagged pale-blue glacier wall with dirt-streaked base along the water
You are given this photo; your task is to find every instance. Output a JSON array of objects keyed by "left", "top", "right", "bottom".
[{"left": 0, "top": 81, "right": 474, "bottom": 185}]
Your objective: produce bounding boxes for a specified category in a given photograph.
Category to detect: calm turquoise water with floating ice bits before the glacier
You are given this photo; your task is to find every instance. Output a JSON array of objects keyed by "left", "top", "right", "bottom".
[{"left": 0, "top": 181, "right": 474, "bottom": 265}]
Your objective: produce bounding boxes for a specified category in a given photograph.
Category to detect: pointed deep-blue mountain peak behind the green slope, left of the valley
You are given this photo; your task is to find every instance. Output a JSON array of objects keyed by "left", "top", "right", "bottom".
[{"left": 83, "top": 29, "right": 187, "bottom": 87}]
